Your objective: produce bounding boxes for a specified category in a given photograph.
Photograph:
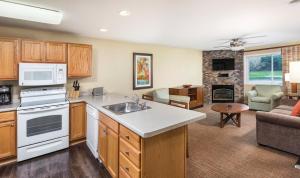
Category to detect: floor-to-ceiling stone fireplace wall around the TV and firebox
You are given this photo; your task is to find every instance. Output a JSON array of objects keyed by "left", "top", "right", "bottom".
[{"left": 203, "top": 50, "right": 244, "bottom": 103}]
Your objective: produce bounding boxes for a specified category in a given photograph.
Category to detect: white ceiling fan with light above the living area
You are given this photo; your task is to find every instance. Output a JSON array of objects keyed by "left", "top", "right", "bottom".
[{"left": 214, "top": 35, "right": 266, "bottom": 51}]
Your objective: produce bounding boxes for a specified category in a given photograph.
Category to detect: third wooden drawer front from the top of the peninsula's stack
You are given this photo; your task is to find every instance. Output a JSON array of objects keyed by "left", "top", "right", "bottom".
[{"left": 120, "top": 153, "right": 141, "bottom": 178}]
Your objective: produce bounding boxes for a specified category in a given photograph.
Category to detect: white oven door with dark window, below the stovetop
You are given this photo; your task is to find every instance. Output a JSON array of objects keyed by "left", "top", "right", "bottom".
[{"left": 17, "top": 104, "right": 69, "bottom": 147}]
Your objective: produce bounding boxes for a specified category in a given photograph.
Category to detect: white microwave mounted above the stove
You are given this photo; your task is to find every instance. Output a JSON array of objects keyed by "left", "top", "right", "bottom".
[{"left": 19, "top": 63, "right": 56, "bottom": 86}]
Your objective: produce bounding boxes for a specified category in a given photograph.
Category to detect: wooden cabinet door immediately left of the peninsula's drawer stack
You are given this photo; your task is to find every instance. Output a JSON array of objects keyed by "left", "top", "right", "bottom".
[{"left": 106, "top": 128, "right": 119, "bottom": 177}]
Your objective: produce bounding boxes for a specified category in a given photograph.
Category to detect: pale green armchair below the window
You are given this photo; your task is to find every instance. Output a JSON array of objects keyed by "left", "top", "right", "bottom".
[{"left": 247, "top": 85, "right": 284, "bottom": 111}]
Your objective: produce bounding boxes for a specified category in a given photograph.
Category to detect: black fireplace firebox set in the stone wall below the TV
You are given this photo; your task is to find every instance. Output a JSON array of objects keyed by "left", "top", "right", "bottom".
[{"left": 212, "top": 85, "right": 234, "bottom": 103}]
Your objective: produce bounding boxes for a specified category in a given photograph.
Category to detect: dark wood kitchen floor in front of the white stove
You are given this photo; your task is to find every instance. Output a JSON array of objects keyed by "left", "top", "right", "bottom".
[{"left": 0, "top": 143, "right": 110, "bottom": 178}]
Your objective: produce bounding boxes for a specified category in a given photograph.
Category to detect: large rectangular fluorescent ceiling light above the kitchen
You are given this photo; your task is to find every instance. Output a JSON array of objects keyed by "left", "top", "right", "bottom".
[{"left": 0, "top": 1, "right": 63, "bottom": 25}]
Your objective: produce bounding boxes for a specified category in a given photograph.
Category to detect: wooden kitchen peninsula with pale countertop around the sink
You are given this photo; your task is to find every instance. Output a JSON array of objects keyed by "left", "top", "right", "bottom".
[{"left": 70, "top": 94, "right": 206, "bottom": 178}]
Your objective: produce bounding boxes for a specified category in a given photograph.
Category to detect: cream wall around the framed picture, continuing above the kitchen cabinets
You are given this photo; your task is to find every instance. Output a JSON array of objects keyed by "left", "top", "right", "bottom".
[{"left": 0, "top": 26, "right": 202, "bottom": 98}]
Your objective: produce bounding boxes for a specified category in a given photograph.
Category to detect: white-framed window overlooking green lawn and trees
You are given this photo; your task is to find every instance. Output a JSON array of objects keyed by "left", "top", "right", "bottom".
[{"left": 244, "top": 52, "right": 282, "bottom": 85}]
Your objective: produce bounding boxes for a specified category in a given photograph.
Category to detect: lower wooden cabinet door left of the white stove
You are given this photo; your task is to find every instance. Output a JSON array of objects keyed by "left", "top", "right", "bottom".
[{"left": 0, "top": 121, "right": 16, "bottom": 159}]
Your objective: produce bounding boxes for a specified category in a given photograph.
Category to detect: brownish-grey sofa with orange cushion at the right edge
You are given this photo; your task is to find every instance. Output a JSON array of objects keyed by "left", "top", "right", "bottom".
[{"left": 256, "top": 102, "right": 300, "bottom": 155}]
